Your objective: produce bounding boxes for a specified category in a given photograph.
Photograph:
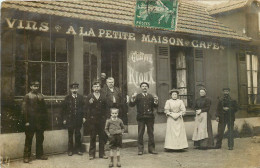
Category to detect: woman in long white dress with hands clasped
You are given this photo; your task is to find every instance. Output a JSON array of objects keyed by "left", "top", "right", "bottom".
[{"left": 164, "top": 89, "right": 188, "bottom": 150}]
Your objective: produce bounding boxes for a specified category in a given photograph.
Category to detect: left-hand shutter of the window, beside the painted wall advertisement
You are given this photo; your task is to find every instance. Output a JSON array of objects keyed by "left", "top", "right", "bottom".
[{"left": 156, "top": 46, "right": 171, "bottom": 112}]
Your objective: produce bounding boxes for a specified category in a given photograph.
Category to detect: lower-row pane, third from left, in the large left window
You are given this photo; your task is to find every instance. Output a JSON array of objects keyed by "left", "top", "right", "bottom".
[{"left": 42, "top": 63, "right": 55, "bottom": 96}]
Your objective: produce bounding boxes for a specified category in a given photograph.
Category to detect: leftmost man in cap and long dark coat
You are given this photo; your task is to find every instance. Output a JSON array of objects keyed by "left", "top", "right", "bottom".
[{"left": 22, "top": 81, "right": 48, "bottom": 163}]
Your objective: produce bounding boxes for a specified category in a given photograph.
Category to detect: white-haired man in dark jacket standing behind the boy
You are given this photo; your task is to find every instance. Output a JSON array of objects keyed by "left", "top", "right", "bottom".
[{"left": 101, "top": 77, "right": 128, "bottom": 125}]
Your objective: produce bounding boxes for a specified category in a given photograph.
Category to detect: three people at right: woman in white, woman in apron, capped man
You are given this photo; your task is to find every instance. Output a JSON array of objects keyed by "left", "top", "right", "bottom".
[{"left": 164, "top": 87, "right": 237, "bottom": 150}]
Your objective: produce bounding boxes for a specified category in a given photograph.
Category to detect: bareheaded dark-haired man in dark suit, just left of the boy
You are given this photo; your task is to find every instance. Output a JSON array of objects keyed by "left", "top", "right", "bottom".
[{"left": 86, "top": 81, "right": 108, "bottom": 160}]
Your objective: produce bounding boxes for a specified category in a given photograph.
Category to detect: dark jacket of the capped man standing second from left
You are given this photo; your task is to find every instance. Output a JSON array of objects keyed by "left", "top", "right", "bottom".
[{"left": 62, "top": 94, "right": 85, "bottom": 128}]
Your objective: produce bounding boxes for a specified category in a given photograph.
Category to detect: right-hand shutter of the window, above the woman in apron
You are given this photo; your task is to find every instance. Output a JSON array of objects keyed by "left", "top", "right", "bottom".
[{"left": 194, "top": 49, "right": 205, "bottom": 98}]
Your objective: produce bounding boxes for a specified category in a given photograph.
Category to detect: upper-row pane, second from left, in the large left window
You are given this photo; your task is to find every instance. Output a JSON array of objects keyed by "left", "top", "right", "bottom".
[{"left": 28, "top": 35, "right": 41, "bottom": 61}]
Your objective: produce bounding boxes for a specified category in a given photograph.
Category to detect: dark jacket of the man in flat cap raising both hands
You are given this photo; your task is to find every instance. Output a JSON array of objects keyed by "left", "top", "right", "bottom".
[{"left": 129, "top": 93, "right": 158, "bottom": 121}]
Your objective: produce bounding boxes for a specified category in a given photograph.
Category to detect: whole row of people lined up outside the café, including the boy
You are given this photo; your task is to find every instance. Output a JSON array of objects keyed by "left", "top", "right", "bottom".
[{"left": 22, "top": 74, "right": 237, "bottom": 167}]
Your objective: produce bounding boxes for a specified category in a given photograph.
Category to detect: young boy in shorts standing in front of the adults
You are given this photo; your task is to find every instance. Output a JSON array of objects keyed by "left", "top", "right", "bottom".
[{"left": 105, "top": 108, "right": 124, "bottom": 167}]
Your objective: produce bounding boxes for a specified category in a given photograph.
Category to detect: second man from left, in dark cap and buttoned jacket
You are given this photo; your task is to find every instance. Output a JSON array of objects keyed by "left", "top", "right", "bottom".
[{"left": 63, "top": 82, "right": 86, "bottom": 156}]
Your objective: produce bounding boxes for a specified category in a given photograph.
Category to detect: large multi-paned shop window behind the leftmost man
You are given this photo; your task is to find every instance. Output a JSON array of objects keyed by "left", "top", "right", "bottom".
[{"left": 15, "top": 32, "right": 69, "bottom": 97}]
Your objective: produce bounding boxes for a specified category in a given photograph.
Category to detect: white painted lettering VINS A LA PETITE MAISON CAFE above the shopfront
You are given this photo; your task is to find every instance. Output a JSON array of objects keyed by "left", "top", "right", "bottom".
[{"left": 5, "top": 18, "right": 224, "bottom": 50}]
